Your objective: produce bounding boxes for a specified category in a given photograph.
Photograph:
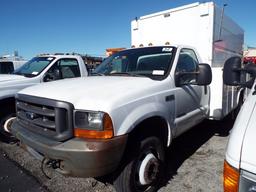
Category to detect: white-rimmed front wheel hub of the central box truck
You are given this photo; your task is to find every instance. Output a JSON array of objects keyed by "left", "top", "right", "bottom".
[{"left": 139, "top": 153, "right": 159, "bottom": 185}]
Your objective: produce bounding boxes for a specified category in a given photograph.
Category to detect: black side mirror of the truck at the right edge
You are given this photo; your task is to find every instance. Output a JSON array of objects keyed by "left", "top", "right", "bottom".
[{"left": 223, "top": 57, "right": 242, "bottom": 86}]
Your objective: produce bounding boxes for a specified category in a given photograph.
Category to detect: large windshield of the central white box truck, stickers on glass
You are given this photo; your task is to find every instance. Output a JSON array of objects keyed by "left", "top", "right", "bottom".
[{"left": 92, "top": 46, "right": 174, "bottom": 79}]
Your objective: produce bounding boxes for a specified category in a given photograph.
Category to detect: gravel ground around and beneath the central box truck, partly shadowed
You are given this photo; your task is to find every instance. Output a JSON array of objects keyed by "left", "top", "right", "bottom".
[{"left": 0, "top": 117, "right": 233, "bottom": 192}]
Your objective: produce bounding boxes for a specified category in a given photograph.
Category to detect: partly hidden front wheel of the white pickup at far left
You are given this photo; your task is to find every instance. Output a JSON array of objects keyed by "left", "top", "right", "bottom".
[{"left": 0, "top": 114, "right": 18, "bottom": 143}]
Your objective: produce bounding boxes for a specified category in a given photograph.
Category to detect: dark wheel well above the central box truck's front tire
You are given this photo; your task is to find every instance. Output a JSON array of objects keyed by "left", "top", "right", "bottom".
[{"left": 128, "top": 117, "right": 168, "bottom": 146}]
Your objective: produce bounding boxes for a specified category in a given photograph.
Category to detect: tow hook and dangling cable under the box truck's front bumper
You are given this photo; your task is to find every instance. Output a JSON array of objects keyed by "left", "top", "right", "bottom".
[{"left": 41, "top": 158, "right": 61, "bottom": 179}]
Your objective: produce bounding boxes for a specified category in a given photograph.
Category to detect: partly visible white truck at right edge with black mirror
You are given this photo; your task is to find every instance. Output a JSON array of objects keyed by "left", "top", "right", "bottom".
[{"left": 223, "top": 59, "right": 256, "bottom": 192}]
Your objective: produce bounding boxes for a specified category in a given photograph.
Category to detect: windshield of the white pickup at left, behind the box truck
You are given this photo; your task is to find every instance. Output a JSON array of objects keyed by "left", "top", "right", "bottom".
[{"left": 13, "top": 57, "right": 54, "bottom": 77}]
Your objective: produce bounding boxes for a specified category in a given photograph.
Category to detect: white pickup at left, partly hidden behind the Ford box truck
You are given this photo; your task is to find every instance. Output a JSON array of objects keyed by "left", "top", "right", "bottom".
[{"left": 0, "top": 54, "right": 88, "bottom": 142}]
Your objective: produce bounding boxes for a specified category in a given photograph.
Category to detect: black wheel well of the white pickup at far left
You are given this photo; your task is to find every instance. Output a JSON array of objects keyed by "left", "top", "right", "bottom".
[{"left": 0, "top": 97, "right": 15, "bottom": 118}]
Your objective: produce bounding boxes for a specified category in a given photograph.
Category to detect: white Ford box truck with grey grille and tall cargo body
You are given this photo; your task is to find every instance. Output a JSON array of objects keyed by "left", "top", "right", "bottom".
[{"left": 11, "top": 2, "right": 243, "bottom": 191}]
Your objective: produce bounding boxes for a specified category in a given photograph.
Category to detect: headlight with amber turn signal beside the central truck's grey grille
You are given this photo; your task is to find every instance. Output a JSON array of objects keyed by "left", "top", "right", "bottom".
[{"left": 74, "top": 111, "right": 113, "bottom": 139}]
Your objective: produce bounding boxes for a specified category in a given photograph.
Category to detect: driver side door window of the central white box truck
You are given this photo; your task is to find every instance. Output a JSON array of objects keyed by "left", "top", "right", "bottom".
[{"left": 175, "top": 49, "right": 199, "bottom": 84}]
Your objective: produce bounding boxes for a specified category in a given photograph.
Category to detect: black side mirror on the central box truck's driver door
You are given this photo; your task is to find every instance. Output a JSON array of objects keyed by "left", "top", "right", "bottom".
[{"left": 196, "top": 63, "right": 212, "bottom": 85}]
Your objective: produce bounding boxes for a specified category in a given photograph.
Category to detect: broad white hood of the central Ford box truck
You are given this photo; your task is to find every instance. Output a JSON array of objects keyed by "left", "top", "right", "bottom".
[{"left": 19, "top": 76, "right": 160, "bottom": 112}]
